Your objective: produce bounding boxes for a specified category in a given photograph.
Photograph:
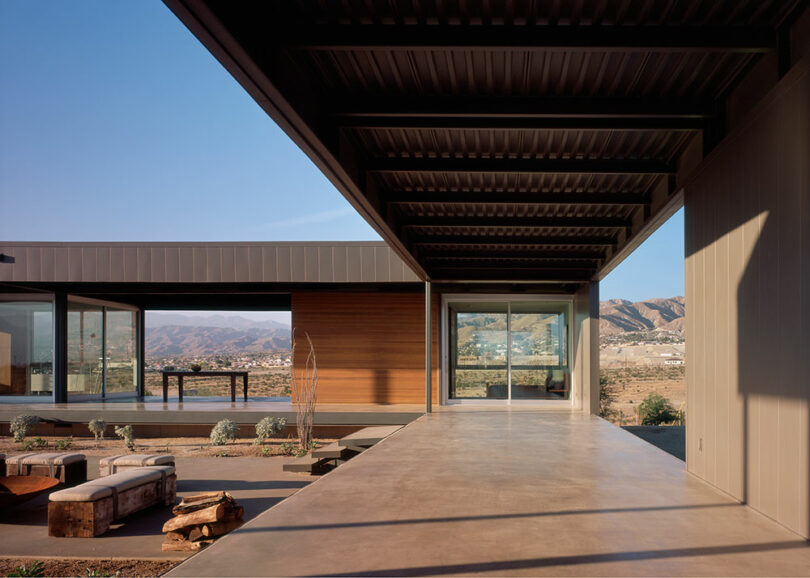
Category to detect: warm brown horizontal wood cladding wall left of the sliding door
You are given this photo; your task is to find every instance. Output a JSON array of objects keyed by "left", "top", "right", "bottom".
[{"left": 292, "top": 293, "right": 439, "bottom": 404}]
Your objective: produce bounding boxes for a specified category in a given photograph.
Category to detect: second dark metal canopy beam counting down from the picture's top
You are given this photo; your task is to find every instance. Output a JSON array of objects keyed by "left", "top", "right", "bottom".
[{"left": 332, "top": 95, "right": 716, "bottom": 118}]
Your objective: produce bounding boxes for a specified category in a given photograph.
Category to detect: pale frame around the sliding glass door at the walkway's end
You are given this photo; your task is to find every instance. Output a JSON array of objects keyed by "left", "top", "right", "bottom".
[{"left": 439, "top": 293, "right": 579, "bottom": 408}]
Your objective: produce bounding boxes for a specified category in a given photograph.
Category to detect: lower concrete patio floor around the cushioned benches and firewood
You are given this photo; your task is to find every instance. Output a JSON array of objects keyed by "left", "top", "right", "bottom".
[{"left": 0, "top": 456, "right": 314, "bottom": 560}]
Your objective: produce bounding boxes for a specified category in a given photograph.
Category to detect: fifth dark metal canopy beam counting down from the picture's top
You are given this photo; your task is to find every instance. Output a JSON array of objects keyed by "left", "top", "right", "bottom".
[{"left": 399, "top": 215, "right": 631, "bottom": 229}]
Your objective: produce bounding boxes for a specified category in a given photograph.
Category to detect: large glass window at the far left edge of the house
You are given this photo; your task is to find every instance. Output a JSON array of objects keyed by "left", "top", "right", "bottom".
[{"left": 0, "top": 300, "right": 53, "bottom": 398}]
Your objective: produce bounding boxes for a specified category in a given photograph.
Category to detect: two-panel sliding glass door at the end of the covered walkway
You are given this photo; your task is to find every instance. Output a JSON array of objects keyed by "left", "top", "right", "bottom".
[{"left": 448, "top": 301, "right": 571, "bottom": 400}]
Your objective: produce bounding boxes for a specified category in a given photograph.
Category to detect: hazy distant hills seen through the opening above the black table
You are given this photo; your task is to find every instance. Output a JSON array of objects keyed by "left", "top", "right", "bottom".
[{"left": 146, "top": 312, "right": 290, "bottom": 357}]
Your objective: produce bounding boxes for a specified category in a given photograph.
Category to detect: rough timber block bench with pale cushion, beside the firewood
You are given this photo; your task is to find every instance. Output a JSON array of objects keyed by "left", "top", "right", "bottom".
[{"left": 48, "top": 466, "right": 177, "bottom": 538}]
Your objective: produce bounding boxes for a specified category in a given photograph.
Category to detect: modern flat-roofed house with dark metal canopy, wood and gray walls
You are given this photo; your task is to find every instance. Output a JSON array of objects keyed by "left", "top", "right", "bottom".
[{"left": 0, "top": 0, "right": 810, "bottom": 538}]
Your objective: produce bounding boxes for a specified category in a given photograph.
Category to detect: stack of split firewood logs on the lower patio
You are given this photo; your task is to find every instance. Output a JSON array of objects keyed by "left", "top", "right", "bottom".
[{"left": 163, "top": 492, "right": 244, "bottom": 552}]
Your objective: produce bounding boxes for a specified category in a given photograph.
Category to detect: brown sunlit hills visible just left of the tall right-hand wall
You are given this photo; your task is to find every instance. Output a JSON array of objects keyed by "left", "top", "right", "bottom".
[{"left": 599, "top": 297, "right": 686, "bottom": 335}]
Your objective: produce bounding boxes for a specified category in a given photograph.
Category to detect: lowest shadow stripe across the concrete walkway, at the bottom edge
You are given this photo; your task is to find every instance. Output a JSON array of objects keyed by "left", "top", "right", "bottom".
[{"left": 318, "top": 540, "right": 810, "bottom": 576}]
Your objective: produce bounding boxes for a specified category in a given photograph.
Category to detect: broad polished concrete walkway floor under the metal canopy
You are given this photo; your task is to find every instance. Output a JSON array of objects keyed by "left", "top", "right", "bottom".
[{"left": 169, "top": 410, "right": 810, "bottom": 576}]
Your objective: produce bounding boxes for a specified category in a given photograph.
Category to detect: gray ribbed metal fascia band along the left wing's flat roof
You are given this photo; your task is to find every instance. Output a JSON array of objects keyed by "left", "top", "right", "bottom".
[{"left": 0, "top": 241, "right": 419, "bottom": 283}]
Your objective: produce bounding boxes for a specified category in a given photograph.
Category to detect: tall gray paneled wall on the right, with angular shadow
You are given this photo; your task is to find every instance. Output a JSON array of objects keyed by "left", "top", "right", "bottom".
[{"left": 685, "top": 57, "right": 810, "bottom": 537}]
